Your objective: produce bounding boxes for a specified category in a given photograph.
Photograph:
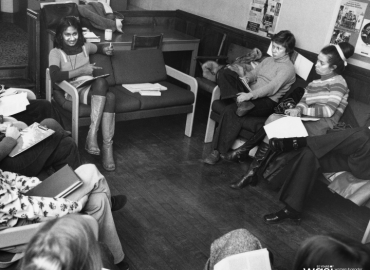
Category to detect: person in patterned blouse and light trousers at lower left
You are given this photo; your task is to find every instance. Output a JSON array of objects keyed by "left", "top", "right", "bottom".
[{"left": 0, "top": 164, "right": 126, "bottom": 264}]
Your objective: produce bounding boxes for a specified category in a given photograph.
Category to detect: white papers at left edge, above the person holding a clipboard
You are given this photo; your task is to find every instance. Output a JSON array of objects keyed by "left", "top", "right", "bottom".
[{"left": 0, "top": 93, "right": 30, "bottom": 116}]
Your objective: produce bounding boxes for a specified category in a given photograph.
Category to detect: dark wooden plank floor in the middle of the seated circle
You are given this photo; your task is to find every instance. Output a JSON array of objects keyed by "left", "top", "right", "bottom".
[{"left": 79, "top": 95, "right": 370, "bottom": 270}]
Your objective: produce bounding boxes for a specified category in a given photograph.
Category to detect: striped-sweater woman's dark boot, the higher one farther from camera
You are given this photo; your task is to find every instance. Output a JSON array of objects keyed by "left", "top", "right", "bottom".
[{"left": 221, "top": 127, "right": 266, "bottom": 162}]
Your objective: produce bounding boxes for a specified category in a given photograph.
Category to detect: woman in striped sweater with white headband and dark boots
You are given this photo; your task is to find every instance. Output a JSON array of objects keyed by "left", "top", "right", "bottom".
[{"left": 228, "top": 42, "right": 354, "bottom": 189}]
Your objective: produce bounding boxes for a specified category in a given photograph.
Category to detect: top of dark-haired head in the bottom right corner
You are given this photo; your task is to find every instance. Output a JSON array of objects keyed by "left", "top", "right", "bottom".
[{"left": 293, "top": 234, "right": 370, "bottom": 270}]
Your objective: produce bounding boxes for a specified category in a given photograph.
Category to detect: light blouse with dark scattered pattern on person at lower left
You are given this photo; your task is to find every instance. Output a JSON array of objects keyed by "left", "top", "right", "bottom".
[{"left": 0, "top": 170, "right": 82, "bottom": 227}]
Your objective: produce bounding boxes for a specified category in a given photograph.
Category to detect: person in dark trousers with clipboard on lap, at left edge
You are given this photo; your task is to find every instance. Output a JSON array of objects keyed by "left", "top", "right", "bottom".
[{"left": 0, "top": 119, "right": 81, "bottom": 176}]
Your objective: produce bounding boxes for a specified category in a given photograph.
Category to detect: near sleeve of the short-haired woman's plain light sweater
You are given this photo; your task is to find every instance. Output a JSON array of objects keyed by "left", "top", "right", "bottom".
[{"left": 252, "top": 61, "right": 295, "bottom": 99}]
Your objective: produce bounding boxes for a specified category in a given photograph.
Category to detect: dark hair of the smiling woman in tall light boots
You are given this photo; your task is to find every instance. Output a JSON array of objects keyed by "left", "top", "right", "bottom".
[{"left": 54, "top": 16, "right": 86, "bottom": 49}]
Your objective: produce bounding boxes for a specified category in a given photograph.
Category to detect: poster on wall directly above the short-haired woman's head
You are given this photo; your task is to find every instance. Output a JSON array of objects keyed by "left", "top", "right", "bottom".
[{"left": 246, "top": 0, "right": 283, "bottom": 37}]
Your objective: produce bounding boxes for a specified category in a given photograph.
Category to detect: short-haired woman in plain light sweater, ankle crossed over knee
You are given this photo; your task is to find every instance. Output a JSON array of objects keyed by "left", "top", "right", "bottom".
[{"left": 204, "top": 31, "right": 295, "bottom": 165}]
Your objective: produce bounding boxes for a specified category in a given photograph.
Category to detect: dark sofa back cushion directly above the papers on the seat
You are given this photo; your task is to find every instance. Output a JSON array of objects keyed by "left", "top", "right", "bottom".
[{"left": 111, "top": 49, "right": 167, "bottom": 84}]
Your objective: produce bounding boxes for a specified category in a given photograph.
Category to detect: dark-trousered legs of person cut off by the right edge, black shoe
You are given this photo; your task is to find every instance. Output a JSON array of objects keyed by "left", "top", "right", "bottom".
[{"left": 263, "top": 127, "right": 370, "bottom": 224}]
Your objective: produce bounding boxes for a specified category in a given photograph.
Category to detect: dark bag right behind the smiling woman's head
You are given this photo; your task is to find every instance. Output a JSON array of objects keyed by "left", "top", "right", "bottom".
[{"left": 41, "top": 3, "right": 80, "bottom": 29}]
